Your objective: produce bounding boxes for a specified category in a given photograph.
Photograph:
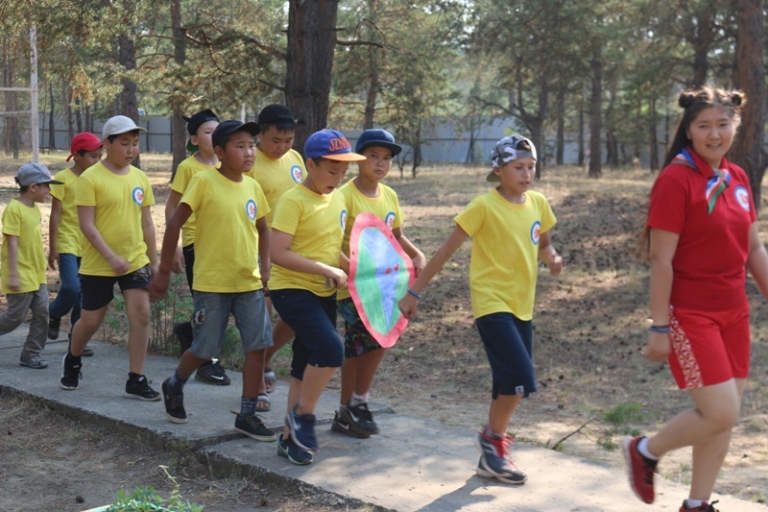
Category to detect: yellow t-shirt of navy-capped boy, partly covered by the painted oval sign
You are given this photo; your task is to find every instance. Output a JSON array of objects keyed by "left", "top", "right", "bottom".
[{"left": 336, "top": 180, "right": 403, "bottom": 300}]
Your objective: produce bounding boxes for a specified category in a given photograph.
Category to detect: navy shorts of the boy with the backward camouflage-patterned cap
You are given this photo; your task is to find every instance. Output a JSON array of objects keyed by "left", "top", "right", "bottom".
[{"left": 475, "top": 313, "right": 536, "bottom": 399}]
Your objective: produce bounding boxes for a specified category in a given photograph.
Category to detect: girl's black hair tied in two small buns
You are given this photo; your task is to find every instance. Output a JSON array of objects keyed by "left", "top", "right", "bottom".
[{"left": 662, "top": 85, "right": 747, "bottom": 168}]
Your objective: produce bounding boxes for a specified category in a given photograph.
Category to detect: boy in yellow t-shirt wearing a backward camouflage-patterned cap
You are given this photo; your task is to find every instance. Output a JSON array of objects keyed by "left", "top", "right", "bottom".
[{"left": 400, "top": 135, "right": 563, "bottom": 484}]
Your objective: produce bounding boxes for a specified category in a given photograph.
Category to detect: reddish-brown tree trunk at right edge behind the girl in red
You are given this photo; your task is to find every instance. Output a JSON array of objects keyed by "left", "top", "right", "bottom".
[{"left": 729, "top": 0, "right": 768, "bottom": 210}]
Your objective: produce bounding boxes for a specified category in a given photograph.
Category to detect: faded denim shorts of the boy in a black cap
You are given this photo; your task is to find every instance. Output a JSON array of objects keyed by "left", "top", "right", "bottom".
[{"left": 192, "top": 290, "right": 272, "bottom": 359}]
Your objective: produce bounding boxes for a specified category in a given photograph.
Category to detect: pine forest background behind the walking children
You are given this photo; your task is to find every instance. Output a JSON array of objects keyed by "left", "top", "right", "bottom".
[{"left": 0, "top": 0, "right": 768, "bottom": 198}]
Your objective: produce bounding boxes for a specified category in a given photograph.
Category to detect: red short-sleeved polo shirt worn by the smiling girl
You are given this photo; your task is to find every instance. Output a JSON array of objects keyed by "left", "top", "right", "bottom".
[{"left": 647, "top": 148, "right": 757, "bottom": 311}]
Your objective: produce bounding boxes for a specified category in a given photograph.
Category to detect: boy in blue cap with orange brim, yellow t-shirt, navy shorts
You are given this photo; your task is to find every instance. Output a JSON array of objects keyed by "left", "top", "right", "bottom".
[{"left": 269, "top": 130, "right": 365, "bottom": 464}]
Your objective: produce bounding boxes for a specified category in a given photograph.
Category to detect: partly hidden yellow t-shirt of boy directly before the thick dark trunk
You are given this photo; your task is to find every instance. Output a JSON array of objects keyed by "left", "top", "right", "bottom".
[{"left": 246, "top": 148, "right": 307, "bottom": 226}]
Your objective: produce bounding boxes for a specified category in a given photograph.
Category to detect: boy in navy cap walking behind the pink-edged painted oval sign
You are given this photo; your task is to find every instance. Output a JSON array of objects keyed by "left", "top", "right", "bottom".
[{"left": 331, "top": 129, "right": 426, "bottom": 438}]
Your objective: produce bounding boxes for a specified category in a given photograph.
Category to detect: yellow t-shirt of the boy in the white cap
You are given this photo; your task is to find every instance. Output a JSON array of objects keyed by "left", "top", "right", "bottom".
[{"left": 75, "top": 163, "right": 155, "bottom": 277}]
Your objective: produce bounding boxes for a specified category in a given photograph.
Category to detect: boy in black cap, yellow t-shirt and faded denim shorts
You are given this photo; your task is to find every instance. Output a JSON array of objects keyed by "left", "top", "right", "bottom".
[{"left": 150, "top": 121, "right": 275, "bottom": 441}]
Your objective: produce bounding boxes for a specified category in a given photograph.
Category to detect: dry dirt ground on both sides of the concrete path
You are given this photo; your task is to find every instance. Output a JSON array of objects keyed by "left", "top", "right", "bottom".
[{"left": 0, "top": 155, "right": 768, "bottom": 510}]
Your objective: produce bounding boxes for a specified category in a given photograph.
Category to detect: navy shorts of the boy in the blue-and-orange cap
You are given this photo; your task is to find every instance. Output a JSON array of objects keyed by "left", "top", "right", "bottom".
[{"left": 269, "top": 288, "right": 344, "bottom": 380}]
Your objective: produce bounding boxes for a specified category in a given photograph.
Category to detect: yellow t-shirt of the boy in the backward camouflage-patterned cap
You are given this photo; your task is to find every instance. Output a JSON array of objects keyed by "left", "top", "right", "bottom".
[{"left": 454, "top": 189, "right": 557, "bottom": 320}]
